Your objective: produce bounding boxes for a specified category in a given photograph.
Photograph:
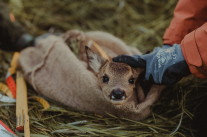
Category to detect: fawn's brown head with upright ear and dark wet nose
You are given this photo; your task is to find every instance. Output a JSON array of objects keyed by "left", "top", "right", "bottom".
[{"left": 86, "top": 46, "right": 142, "bottom": 105}]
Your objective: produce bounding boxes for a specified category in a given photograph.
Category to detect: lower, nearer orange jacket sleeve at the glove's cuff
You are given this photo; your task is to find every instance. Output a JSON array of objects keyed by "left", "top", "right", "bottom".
[{"left": 181, "top": 23, "right": 207, "bottom": 78}]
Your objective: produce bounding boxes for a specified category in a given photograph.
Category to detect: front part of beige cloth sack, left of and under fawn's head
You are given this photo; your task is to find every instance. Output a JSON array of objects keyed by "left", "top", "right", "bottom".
[{"left": 18, "top": 36, "right": 163, "bottom": 120}]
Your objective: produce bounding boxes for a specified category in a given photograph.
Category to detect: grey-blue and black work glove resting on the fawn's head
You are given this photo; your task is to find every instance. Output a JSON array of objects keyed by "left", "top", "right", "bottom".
[{"left": 113, "top": 44, "right": 191, "bottom": 86}]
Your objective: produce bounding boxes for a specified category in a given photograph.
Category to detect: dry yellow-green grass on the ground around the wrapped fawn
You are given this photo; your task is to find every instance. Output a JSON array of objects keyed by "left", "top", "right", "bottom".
[{"left": 0, "top": 0, "right": 207, "bottom": 137}]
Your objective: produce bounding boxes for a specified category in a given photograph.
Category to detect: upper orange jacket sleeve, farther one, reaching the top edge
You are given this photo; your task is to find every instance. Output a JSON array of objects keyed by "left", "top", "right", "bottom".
[{"left": 163, "top": 0, "right": 207, "bottom": 45}]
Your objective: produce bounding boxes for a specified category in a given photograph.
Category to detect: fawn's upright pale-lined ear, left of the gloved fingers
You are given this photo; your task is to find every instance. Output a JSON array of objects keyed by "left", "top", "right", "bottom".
[{"left": 85, "top": 46, "right": 107, "bottom": 73}]
